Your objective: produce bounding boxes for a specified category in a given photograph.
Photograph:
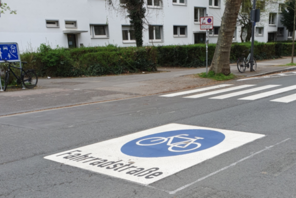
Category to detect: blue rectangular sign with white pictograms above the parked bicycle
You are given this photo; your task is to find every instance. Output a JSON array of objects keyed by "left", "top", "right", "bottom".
[{"left": 0, "top": 43, "right": 20, "bottom": 62}]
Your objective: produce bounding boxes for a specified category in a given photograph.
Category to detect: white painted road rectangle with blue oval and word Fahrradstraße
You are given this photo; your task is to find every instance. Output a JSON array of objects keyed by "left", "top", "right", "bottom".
[{"left": 44, "top": 124, "right": 264, "bottom": 185}]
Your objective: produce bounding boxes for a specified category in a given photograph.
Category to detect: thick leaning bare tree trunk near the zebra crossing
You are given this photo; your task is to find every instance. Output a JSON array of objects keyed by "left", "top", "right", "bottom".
[{"left": 210, "top": 0, "right": 242, "bottom": 75}]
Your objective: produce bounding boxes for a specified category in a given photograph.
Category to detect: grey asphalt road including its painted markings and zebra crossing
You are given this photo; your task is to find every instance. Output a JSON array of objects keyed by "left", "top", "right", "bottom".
[{"left": 0, "top": 74, "right": 296, "bottom": 198}]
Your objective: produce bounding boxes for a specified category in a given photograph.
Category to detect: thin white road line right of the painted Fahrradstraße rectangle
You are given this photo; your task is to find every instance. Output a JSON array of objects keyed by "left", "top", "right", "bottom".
[{"left": 165, "top": 138, "right": 290, "bottom": 195}]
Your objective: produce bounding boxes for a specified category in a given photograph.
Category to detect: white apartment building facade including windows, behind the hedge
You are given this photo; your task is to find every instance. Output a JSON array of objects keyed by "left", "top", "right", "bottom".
[{"left": 0, "top": 0, "right": 292, "bottom": 52}]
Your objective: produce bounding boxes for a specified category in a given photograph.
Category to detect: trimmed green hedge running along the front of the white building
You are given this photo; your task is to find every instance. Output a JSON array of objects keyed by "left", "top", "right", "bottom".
[{"left": 17, "top": 42, "right": 296, "bottom": 77}]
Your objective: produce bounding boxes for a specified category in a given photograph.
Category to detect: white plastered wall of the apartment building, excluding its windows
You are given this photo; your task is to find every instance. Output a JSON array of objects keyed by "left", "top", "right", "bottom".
[{"left": 0, "top": 0, "right": 287, "bottom": 52}]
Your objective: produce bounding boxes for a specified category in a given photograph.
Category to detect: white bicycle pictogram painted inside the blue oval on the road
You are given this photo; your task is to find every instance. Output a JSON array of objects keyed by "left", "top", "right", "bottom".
[{"left": 136, "top": 134, "right": 204, "bottom": 152}]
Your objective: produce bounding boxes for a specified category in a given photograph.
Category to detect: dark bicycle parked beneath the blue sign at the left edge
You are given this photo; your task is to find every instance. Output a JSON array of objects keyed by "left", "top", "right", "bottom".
[{"left": 3, "top": 61, "right": 38, "bottom": 91}]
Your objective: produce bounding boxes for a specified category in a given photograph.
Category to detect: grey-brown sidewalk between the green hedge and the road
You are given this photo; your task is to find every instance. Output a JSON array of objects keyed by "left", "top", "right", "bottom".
[{"left": 0, "top": 57, "right": 296, "bottom": 117}]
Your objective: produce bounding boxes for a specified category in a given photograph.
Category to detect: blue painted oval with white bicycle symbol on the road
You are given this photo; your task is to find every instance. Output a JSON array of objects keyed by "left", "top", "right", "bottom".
[{"left": 121, "top": 129, "right": 225, "bottom": 157}]
